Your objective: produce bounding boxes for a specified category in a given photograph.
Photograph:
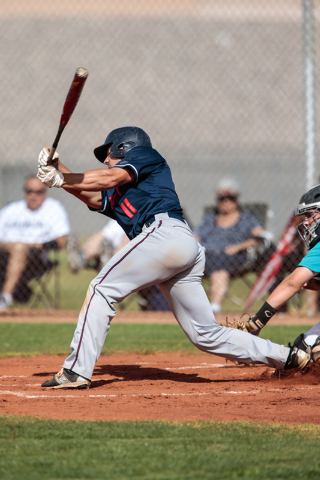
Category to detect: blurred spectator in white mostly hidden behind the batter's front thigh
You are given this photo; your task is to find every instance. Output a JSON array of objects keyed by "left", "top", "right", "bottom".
[{"left": 67, "top": 219, "right": 129, "bottom": 273}]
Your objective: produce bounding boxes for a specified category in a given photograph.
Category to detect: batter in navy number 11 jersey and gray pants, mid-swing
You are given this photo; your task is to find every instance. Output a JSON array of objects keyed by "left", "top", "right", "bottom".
[{"left": 38, "top": 127, "right": 311, "bottom": 388}]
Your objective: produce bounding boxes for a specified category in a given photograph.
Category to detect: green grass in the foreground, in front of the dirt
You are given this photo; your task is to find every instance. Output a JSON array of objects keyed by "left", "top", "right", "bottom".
[{"left": 0, "top": 417, "right": 320, "bottom": 480}]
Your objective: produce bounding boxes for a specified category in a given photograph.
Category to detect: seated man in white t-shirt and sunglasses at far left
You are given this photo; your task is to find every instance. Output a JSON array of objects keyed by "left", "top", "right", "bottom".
[{"left": 0, "top": 177, "right": 70, "bottom": 310}]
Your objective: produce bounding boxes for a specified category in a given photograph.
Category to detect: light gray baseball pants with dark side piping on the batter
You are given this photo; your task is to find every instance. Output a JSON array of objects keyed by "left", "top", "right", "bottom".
[{"left": 63, "top": 213, "right": 290, "bottom": 379}]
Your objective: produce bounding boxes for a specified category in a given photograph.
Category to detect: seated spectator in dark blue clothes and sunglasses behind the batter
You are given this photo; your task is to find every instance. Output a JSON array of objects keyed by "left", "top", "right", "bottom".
[{"left": 195, "top": 180, "right": 270, "bottom": 313}]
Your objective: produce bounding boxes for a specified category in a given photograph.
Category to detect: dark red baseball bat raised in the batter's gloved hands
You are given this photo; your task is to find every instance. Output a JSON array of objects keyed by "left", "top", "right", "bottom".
[{"left": 47, "top": 67, "right": 89, "bottom": 165}]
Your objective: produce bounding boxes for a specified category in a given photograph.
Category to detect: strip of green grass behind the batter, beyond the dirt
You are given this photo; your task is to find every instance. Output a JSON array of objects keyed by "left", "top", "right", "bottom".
[{"left": 0, "top": 323, "right": 311, "bottom": 357}]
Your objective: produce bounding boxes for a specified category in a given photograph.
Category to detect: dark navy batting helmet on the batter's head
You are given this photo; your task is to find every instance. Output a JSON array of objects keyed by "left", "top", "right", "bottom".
[{"left": 93, "top": 127, "right": 152, "bottom": 163}]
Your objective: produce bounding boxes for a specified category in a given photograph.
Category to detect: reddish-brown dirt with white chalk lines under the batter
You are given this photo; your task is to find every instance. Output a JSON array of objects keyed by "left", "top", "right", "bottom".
[{"left": 0, "top": 353, "right": 320, "bottom": 424}]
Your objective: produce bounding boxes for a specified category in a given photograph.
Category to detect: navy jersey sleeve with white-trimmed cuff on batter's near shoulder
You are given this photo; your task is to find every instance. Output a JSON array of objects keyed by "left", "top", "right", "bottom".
[{"left": 112, "top": 147, "right": 165, "bottom": 182}]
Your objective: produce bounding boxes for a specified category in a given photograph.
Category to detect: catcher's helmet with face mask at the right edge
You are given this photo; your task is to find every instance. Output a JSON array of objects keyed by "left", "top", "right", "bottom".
[{"left": 295, "top": 185, "right": 320, "bottom": 250}]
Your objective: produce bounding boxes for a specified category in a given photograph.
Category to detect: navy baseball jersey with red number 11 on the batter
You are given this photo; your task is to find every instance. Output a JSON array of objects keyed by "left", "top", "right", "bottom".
[{"left": 90, "top": 147, "right": 183, "bottom": 240}]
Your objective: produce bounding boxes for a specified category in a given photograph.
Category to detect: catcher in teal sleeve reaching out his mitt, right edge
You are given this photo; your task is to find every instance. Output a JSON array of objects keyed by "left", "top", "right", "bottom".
[{"left": 241, "top": 185, "right": 320, "bottom": 365}]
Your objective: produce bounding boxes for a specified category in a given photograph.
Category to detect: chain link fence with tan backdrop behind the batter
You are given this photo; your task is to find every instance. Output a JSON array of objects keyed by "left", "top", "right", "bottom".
[{"left": 0, "top": 0, "right": 320, "bottom": 314}]
